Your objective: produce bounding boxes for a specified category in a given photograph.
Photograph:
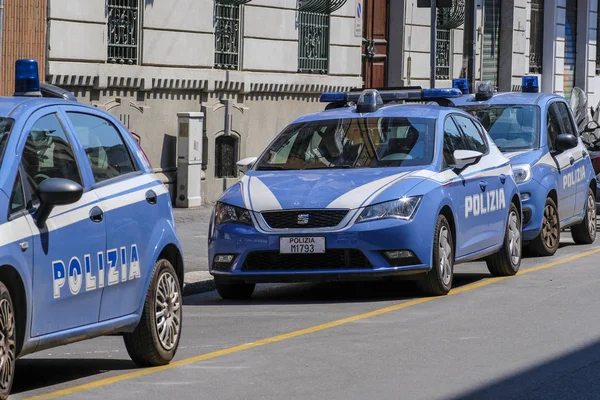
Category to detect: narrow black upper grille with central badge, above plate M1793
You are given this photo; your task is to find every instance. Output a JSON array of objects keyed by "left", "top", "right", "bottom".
[{"left": 262, "top": 210, "right": 348, "bottom": 229}]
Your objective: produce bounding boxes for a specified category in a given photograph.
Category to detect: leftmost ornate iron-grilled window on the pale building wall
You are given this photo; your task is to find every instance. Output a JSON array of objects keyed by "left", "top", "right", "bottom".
[{"left": 108, "top": 0, "right": 140, "bottom": 65}]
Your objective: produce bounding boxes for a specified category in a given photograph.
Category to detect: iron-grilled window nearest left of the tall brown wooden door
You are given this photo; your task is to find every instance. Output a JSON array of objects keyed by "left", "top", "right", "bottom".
[{"left": 298, "top": 11, "right": 329, "bottom": 74}]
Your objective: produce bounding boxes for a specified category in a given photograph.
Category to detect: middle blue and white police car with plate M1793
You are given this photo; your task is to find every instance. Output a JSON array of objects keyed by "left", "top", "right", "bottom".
[{"left": 208, "top": 89, "right": 521, "bottom": 299}]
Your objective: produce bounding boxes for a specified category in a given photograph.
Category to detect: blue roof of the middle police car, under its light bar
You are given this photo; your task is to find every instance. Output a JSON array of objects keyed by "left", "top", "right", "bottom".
[{"left": 292, "top": 104, "right": 469, "bottom": 124}]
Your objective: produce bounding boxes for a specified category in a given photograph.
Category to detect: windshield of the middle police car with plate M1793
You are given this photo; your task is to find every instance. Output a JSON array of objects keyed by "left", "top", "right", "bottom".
[{"left": 256, "top": 117, "right": 436, "bottom": 170}]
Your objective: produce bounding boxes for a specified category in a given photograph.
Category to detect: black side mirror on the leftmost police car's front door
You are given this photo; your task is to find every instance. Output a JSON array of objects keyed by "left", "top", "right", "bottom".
[{"left": 35, "top": 178, "right": 83, "bottom": 229}]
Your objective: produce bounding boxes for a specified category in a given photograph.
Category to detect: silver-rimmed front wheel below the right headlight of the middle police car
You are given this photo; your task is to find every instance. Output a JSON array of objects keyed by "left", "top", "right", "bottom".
[{"left": 417, "top": 214, "right": 454, "bottom": 296}]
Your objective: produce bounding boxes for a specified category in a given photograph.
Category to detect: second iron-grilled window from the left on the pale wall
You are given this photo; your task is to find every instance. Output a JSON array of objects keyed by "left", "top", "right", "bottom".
[{"left": 215, "top": 1, "right": 242, "bottom": 69}]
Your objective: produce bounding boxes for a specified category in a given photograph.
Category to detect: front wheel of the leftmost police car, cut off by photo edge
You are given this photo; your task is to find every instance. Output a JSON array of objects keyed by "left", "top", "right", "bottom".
[{"left": 0, "top": 282, "right": 17, "bottom": 400}]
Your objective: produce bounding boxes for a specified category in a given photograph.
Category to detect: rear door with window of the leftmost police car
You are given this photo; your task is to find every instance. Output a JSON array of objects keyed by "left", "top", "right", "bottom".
[{"left": 65, "top": 107, "right": 156, "bottom": 321}]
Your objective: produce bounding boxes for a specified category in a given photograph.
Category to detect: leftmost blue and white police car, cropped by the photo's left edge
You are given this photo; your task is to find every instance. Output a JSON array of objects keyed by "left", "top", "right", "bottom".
[{"left": 0, "top": 60, "right": 183, "bottom": 398}]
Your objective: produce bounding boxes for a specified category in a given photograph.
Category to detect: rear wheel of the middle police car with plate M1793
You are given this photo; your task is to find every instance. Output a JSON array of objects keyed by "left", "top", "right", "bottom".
[{"left": 485, "top": 203, "right": 523, "bottom": 276}]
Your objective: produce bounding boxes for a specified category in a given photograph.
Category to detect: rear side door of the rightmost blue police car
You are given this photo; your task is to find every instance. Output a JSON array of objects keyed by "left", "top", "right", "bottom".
[{"left": 555, "top": 101, "right": 589, "bottom": 215}]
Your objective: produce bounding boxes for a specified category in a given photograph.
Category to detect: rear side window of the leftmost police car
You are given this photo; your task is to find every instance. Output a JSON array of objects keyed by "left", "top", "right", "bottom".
[{"left": 67, "top": 112, "right": 136, "bottom": 182}]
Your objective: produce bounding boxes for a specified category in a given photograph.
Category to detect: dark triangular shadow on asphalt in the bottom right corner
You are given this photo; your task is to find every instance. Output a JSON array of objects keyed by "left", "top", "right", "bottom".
[{"left": 447, "top": 341, "right": 600, "bottom": 400}]
